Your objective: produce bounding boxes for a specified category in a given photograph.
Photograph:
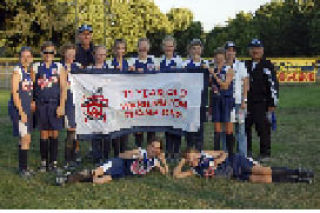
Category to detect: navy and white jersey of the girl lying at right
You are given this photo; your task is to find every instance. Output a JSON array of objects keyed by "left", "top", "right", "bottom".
[{"left": 193, "top": 153, "right": 215, "bottom": 177}]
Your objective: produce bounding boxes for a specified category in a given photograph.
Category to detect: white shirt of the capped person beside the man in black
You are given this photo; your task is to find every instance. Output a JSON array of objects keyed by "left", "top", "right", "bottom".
[{"left": 226, "top": 60, "right": 248, "bottom": 104}]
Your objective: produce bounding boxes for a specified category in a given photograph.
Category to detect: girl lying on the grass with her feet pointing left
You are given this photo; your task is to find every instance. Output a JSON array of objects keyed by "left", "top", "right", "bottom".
[{"left": 56, "top": 140, "right": 168, "bottom": 185}]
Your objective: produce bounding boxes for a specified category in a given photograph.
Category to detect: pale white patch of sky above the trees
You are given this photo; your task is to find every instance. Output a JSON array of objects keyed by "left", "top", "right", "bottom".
[{"left": 154, "top": 0, "right": 270, "bottom": 32}]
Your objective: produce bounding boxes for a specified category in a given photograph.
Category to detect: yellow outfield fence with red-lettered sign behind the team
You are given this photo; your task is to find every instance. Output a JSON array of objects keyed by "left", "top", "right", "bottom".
[{"left": 0, "top": 58, "right": 320, "bottom": 89}]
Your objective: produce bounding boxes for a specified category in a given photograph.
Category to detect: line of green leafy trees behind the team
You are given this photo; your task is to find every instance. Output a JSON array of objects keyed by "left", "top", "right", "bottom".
[{"left": 0, "top": 0, "right": 320, "bottom": 57}]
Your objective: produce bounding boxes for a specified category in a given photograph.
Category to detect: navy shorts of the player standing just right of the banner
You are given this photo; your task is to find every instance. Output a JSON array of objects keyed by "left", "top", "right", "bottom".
[{"left": 212, "top": 95, "right": 234, "bottom": 123}]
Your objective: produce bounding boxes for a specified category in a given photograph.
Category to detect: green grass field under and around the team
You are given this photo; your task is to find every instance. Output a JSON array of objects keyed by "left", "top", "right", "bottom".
[{"left": 0, "top": 84, "right": 320, "bottom": 209}]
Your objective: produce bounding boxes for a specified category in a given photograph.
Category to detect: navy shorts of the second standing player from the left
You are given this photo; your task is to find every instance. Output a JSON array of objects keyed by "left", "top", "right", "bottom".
[{"left": 36, "top": 100, "right": 63, "bottom": 130}]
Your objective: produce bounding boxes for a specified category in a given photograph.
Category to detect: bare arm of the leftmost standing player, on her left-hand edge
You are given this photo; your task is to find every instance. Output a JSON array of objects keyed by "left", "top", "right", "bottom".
[{"left": 11, "top": 71, "right": 27, "bottom": 123}]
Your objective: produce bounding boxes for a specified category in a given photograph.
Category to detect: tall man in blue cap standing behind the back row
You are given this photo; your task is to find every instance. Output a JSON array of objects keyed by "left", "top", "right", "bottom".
[{"left": 76, "top": 24, "right": 94, "bottom": 68}]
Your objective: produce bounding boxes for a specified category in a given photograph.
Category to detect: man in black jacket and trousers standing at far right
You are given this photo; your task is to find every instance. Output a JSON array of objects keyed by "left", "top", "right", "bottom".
[{"left": 246, "top": 39, "right": 279, "bottom": 161}]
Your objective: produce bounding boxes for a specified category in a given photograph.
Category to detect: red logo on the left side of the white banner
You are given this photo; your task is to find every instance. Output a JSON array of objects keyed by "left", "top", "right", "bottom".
[{"left": 81, "top": 88, "right": 109, "bottom": 123}]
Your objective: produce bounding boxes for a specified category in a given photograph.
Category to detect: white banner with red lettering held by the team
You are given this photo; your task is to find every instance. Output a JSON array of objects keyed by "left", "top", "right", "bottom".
[{"left": 71, "top": 70, "right": 204, "bottom": 135}]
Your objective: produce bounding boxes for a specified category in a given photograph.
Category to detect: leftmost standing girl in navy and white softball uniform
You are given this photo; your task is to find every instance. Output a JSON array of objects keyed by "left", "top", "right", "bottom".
[{"left": 8, "top": 47, "right": 35, "bottom": 177}]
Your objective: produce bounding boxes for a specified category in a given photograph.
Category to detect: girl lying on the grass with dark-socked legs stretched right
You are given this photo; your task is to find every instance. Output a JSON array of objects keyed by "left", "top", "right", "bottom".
[{"left": 173, "top": 148, "right": 314, "bottom": 183}]
